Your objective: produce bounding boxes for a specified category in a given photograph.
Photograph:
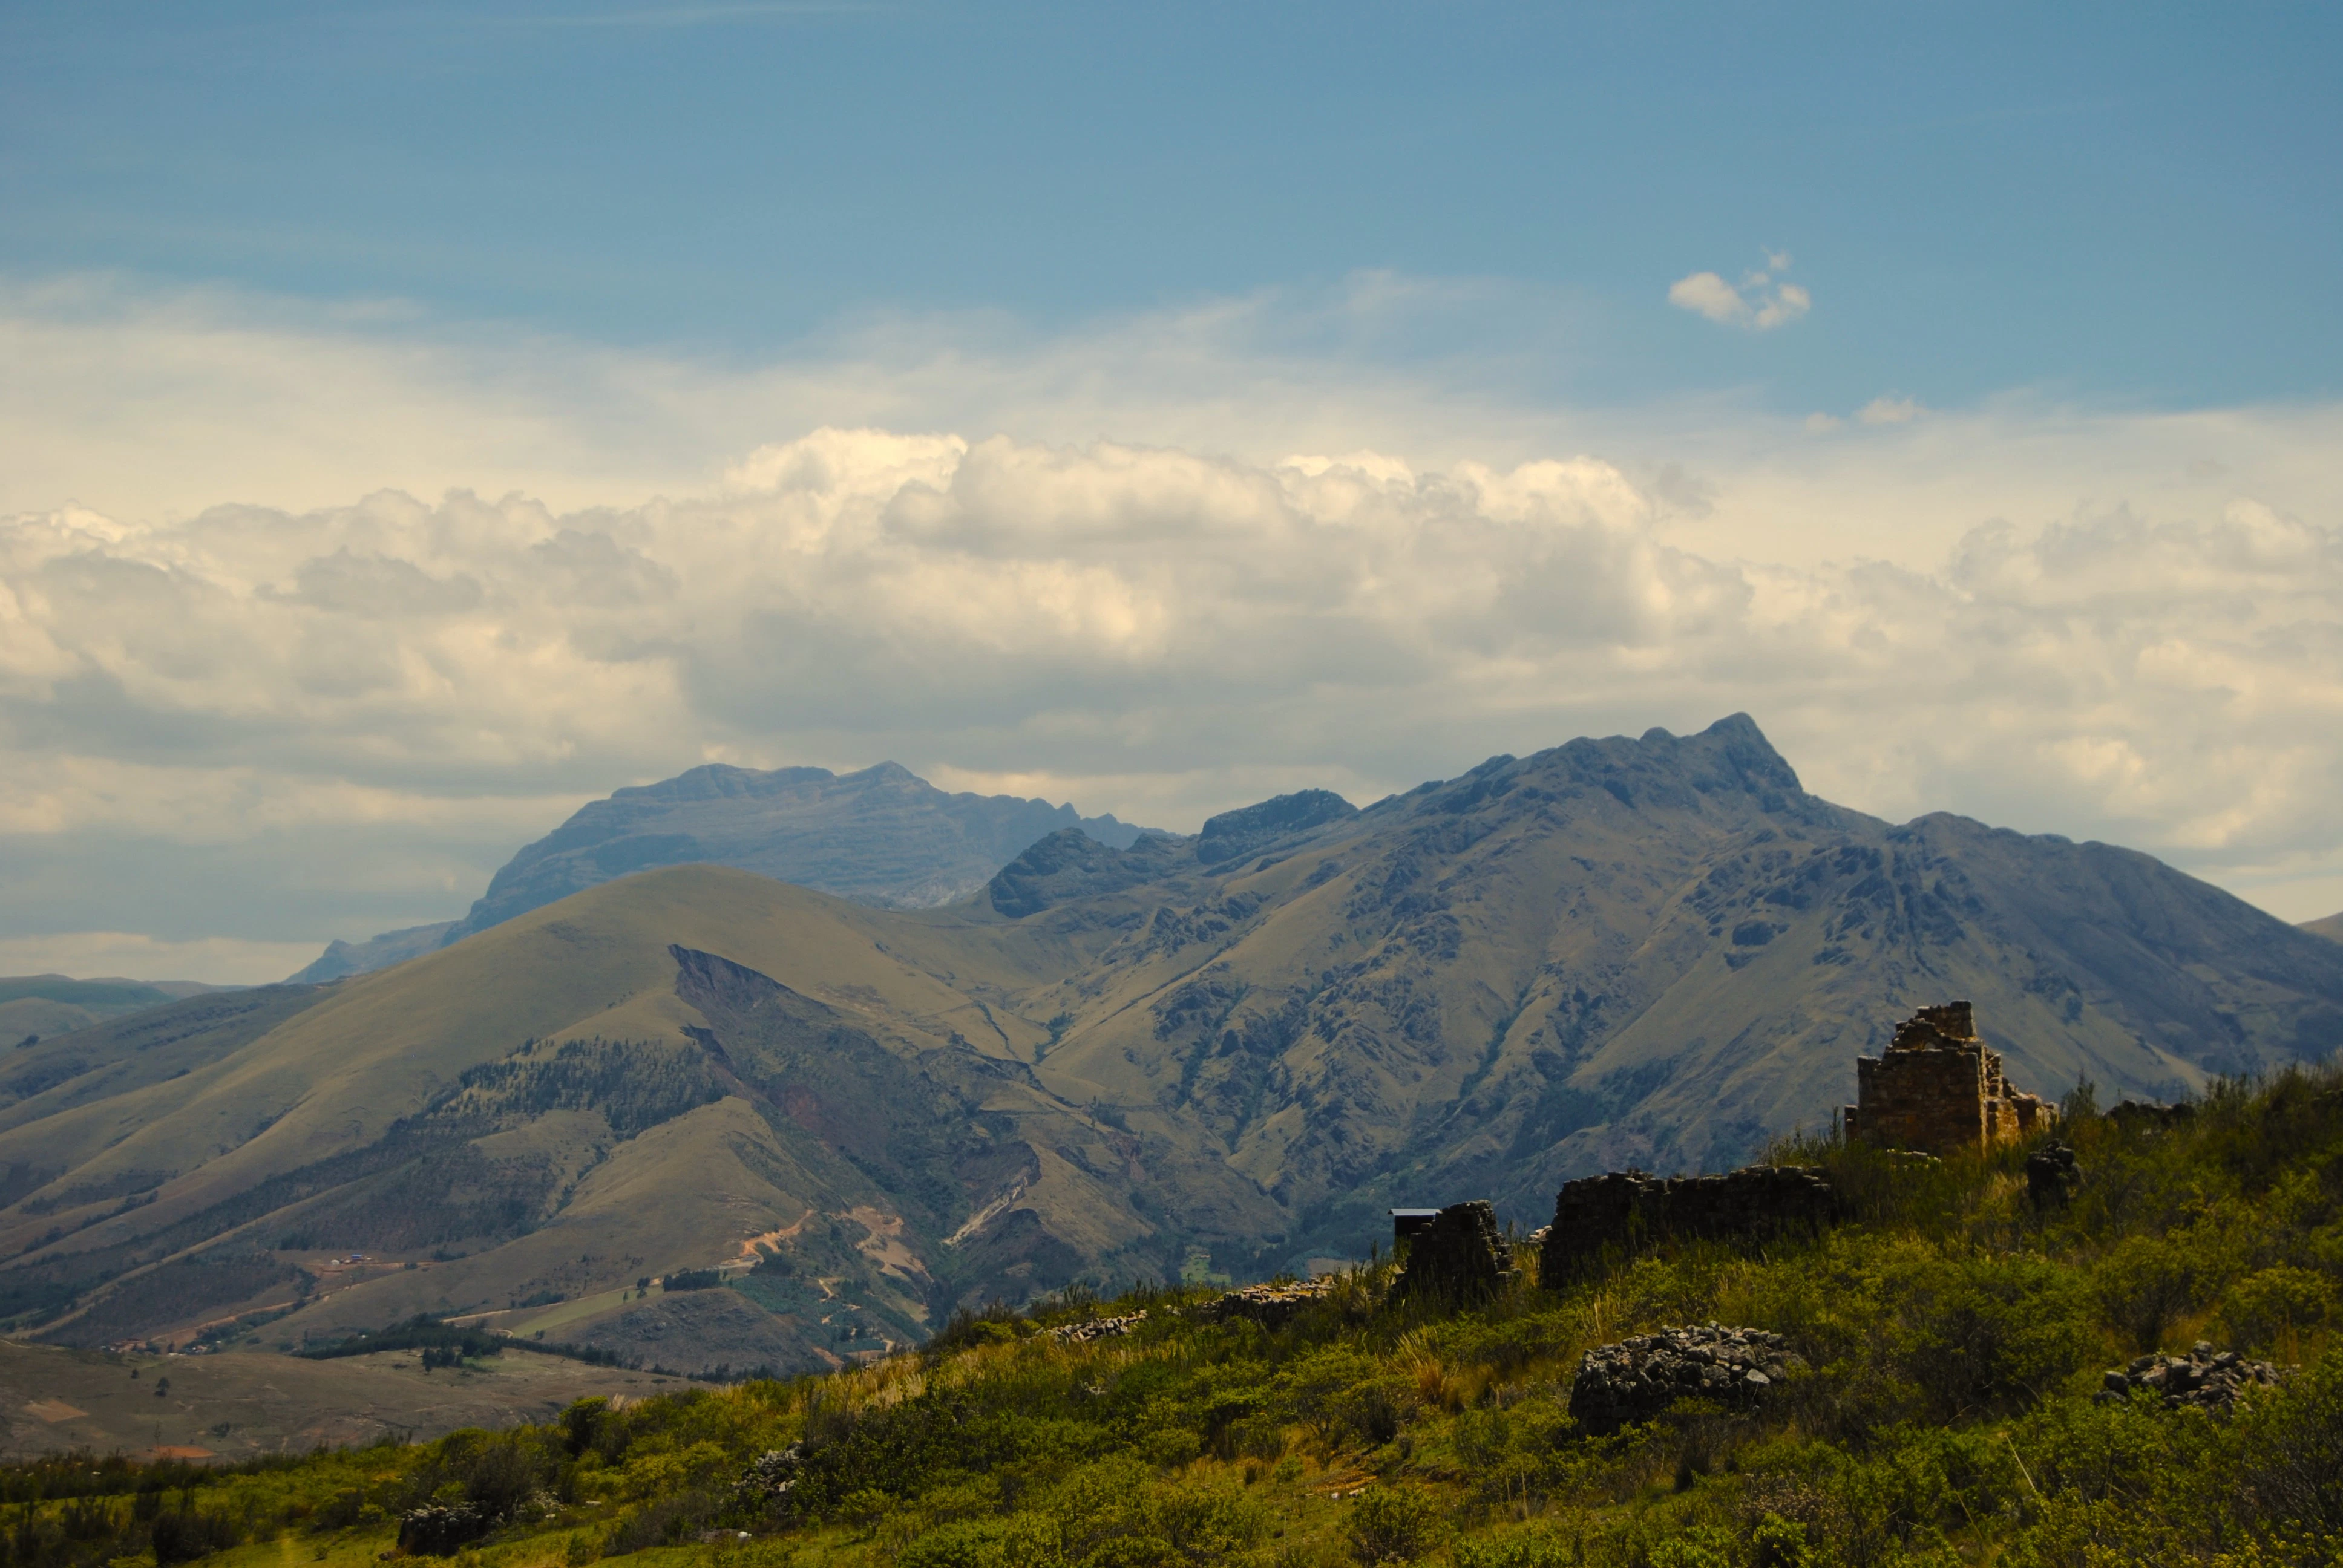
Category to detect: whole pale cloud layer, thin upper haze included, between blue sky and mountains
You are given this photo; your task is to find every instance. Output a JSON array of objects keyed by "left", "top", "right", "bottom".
[{"left": 0, "top": 267, "right": 2343, "bottom": 978}]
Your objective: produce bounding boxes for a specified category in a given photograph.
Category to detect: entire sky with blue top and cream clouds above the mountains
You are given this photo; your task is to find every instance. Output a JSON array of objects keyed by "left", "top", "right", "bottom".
[{"left": 0, "top": 0, "right": 2343, "bottom": 982}]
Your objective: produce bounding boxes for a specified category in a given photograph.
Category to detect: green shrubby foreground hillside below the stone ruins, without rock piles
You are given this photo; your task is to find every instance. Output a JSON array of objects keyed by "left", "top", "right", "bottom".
[{"left": 0, "top": 1069, "right": 2343, "bottom": 1568}]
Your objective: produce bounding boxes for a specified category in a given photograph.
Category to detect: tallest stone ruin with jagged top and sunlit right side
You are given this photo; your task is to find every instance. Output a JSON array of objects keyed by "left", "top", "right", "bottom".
[{"left": 1840, "top": 1001, "right": 2057, "bottom": 1158}]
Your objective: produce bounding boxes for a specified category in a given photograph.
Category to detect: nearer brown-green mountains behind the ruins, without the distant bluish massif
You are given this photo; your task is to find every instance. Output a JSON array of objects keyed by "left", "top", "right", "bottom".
[{"left": 0, "top": 715, "right": 2343, "bottom": 1367}]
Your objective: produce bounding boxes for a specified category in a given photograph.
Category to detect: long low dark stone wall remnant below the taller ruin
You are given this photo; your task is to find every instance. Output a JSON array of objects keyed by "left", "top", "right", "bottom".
[{"left": 1537, "top": 1165, "right": 1840, "bottom": 1289}]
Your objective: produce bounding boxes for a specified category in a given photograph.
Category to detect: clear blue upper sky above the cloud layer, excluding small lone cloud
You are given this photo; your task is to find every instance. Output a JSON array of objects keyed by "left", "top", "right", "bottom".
[{"left": 0, "top": 0, "right": 2343, "bottom": 413}]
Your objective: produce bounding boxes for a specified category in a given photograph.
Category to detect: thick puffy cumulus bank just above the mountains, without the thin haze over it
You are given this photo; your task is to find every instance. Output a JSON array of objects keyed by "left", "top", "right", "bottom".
[{"left": 0, "top": 429, "right": 2343, "bottom": 978}]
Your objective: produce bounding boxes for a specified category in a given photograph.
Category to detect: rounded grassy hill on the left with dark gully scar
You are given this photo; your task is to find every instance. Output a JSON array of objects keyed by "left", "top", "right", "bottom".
[{"left": 0, "top": 867, "right": 1208, "bottom": 1364}]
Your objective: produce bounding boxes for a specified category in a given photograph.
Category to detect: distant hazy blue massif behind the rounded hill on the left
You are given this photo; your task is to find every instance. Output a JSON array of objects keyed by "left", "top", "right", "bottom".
[{"left": 293, "top": 762, "right": 1141, "bottom": 984}]
